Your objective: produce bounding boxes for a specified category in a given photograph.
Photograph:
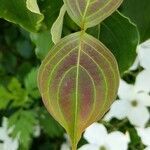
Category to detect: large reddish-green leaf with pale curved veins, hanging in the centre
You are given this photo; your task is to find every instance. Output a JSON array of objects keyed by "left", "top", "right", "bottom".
[{"left": 38, "top": 31, "right": 119, "bottom": 148}]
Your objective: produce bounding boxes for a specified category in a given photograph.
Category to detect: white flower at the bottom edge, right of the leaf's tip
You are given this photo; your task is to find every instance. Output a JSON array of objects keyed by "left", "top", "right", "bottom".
[{"left": 79, "top": 123, "right": 130, "bottom": 150}]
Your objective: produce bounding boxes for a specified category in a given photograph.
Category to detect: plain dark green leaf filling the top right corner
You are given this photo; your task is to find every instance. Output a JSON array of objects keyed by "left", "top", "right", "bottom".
[{"left": 120, "top": 0, "right": 150, "bottom": 42}]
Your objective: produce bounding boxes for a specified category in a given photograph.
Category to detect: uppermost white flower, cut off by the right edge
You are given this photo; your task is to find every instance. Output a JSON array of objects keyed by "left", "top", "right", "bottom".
[{"left": 130, "top": 40, "right": 150, "bottom": 70}]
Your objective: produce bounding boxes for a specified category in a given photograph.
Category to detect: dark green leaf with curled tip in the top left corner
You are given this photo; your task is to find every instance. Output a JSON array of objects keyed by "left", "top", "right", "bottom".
[{"left": 0, "top": 0, "right": 44, "bottom": 32}]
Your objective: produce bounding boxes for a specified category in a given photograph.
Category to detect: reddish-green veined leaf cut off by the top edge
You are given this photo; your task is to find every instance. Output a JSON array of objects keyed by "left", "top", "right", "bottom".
[{"left": 64, "top": 0, "right": 122, "bottom": 29}]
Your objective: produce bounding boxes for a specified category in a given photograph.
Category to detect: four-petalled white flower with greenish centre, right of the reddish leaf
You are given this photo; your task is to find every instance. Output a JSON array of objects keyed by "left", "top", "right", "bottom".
[{"left": 105, "top": 70, "right": 150, "bottom": 127}]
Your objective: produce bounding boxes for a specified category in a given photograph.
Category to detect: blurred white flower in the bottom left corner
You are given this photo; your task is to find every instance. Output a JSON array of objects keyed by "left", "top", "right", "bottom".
[{"left": 0, "top": 118, "right": 19, "bottom": 150}]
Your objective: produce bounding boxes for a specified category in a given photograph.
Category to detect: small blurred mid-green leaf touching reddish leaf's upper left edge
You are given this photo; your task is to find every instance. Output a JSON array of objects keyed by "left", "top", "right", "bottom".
[{"left": 30, "top": 31, "right": 54, "bottom": 60}]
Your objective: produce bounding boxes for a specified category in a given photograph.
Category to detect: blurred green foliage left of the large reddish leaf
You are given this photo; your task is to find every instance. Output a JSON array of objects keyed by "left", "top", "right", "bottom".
[{"left": 0, "top": 19, "right": 64, "bottom": 150}]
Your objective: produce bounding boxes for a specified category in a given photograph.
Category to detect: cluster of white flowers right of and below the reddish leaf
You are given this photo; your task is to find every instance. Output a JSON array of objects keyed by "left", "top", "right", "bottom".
[{"left": 61, "top": 40, "right": 150, "bottom": 150}]
